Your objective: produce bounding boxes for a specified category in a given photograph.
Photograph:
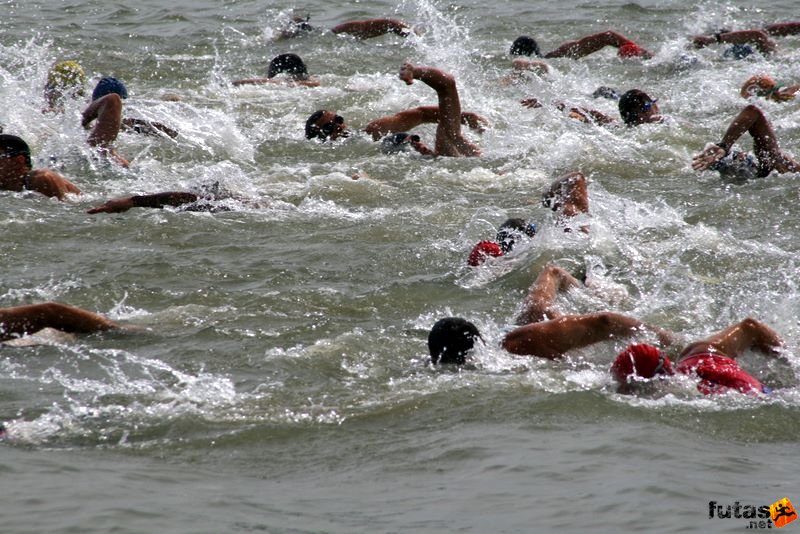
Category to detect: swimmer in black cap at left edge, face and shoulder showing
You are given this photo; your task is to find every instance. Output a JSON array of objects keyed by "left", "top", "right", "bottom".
[{"left": 0, "top": 134, "right": 81, "bottom": 200}]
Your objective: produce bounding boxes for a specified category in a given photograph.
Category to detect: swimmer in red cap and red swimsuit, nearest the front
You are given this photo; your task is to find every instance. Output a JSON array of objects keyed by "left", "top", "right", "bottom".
[{"left": 611, "top": 318, "right": 784, "bottom": 395}]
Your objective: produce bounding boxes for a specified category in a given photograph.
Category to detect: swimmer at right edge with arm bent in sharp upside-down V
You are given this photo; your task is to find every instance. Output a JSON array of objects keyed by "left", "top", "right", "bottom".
[{"left": 692, "top": 104, "right": 800, "bottom": 181}]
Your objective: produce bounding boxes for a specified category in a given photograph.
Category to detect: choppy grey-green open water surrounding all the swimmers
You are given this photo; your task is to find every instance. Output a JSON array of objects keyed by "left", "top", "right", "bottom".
[{"left": 0, "top": 0, "right": 800, "bottom": 533}]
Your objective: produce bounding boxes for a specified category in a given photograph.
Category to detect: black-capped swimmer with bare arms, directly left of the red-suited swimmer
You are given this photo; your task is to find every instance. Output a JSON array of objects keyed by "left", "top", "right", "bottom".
[{"left": 428, "top": 265, "right": 672, "bottom": 365}]
